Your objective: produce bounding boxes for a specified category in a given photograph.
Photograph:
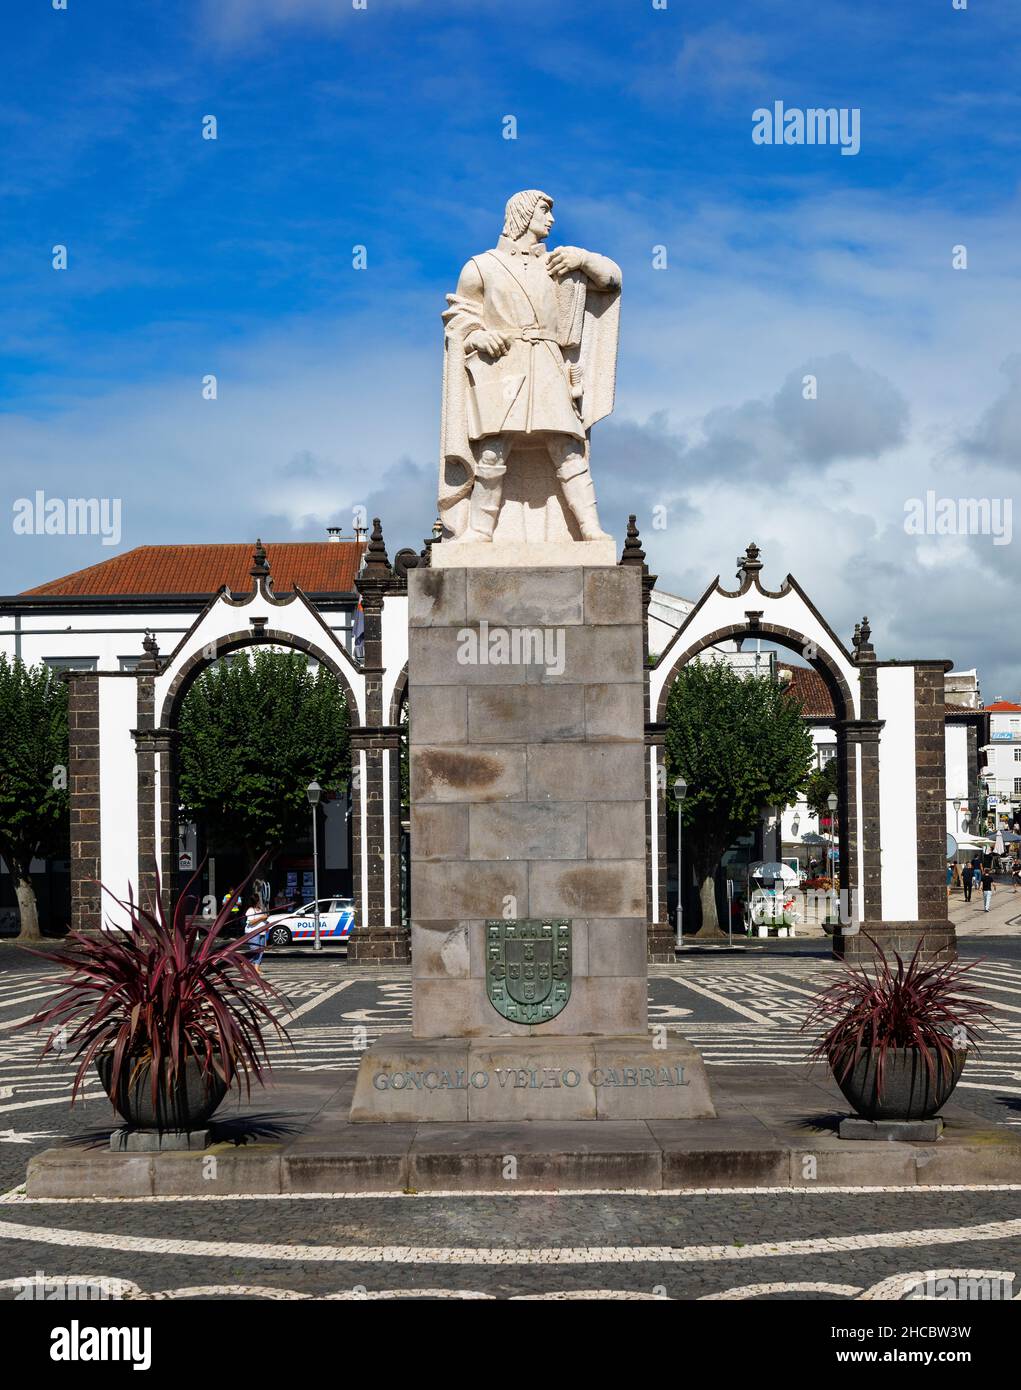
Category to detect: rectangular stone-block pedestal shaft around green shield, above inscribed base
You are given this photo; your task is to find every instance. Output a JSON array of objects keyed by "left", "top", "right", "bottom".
[{"left": 408, "top": 566, "right": 647, "bottom": 1038}]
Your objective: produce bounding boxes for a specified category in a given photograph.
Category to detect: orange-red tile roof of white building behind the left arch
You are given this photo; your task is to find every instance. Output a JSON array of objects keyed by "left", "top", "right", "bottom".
[{"left": 24, "top": 541, "right": 365, "bottom": 598}]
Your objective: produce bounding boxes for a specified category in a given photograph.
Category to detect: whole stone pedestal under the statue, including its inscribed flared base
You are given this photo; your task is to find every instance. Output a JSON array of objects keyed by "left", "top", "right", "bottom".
[{"left": 351, "top": 558, "right": 713, "bottom": 1120}]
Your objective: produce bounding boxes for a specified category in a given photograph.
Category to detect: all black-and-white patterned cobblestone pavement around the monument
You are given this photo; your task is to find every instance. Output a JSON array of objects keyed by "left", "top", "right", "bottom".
[{"left": 0, "top": 941, "right": 1021, "bottom": 1300}]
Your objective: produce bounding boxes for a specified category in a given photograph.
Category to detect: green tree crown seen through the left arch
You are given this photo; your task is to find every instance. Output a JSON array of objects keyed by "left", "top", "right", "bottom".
[{"left": 178, "top": 649, "right": 350, "bottom": 865}]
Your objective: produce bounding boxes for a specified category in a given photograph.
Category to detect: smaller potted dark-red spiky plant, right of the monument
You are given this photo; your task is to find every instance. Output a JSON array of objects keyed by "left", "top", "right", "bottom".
[{"left": 803, "top": 937, "right": 990, "bottom": 1120}]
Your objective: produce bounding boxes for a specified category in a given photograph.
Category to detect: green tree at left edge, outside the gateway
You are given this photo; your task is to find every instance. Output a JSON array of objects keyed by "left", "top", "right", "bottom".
[{"left": 0, "top": 656, "right": 69, "bottom": 941}]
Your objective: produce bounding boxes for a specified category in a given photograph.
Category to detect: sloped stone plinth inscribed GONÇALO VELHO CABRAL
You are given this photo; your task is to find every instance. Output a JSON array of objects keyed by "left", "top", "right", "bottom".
[{"left": 350, "top": 1030, "right": 715, "bottom": 1125}]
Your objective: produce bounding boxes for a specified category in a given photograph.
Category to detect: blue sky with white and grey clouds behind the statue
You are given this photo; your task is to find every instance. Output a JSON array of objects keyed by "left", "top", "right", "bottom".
[{"left": 0, "top": 0, "right": 1021, "bottom": 698}]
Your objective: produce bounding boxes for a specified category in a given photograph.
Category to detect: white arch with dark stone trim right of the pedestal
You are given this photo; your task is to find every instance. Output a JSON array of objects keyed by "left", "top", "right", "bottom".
[{"left": 647, "top": 545, "right": 954, "bottom": 960}]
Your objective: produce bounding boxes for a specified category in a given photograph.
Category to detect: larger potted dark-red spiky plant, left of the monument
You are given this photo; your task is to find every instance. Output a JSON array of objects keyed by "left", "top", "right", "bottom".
[{"left": 24, "top": 880, "right": 288, "bottom": 1131}]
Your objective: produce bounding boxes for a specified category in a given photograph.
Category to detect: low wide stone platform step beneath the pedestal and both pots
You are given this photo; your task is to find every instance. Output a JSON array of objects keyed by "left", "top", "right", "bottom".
[{"left": 21, "top": 1062, "right": 1021, "bottom": 1195}]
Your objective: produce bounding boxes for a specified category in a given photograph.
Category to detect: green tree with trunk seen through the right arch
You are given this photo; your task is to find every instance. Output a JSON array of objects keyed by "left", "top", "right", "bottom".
[{"left": 665, "top": 662, "right": 813, "bottom": 937}]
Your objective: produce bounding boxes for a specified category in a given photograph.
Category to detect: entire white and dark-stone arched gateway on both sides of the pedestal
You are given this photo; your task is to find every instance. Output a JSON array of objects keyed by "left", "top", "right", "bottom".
[{"left": 63, "top": 517, "right": 954, "bottom": 963}]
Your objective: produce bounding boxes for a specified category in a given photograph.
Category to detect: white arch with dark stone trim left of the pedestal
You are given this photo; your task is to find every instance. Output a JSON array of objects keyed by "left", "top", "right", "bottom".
[{"left": 69, "top": 521, "right": 407, "bottom": 960}]
